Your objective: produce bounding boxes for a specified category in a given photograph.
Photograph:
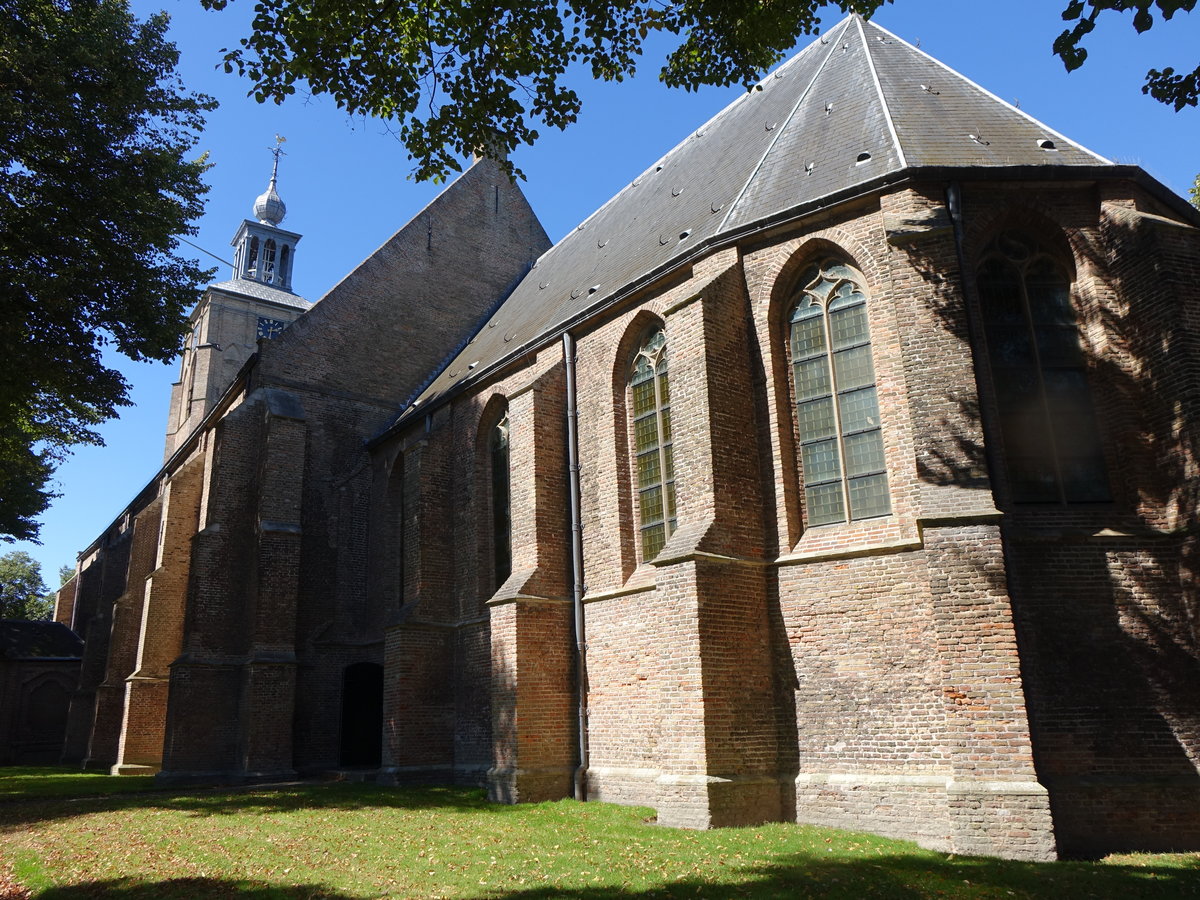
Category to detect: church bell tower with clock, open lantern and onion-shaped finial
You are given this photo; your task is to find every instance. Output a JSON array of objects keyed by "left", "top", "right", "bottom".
[{"left": 163, "top": 134, "right": 312, "bottom": 460}]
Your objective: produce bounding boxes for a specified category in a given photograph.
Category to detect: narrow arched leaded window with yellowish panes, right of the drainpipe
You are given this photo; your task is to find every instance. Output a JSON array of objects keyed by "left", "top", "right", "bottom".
[{"left": 630, "top": 329, "right": 676, "bottom": 559}]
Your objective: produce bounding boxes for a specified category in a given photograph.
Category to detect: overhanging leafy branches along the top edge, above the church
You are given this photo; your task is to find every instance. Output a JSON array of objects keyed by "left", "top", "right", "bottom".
[{"left": 202, "top": 0, "right": 1196, "bottom": 180}]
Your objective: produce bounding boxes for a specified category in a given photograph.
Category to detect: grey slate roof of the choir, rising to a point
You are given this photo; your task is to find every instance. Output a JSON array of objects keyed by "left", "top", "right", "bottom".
[{"left": 401, "top": 17, "right": 1111, "bottom": 420}]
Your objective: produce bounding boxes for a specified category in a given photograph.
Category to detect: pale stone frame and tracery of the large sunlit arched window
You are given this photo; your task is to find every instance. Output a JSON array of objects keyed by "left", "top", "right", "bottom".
[{"left": 781, "top": 251, "right": 894, "bottom": 530}]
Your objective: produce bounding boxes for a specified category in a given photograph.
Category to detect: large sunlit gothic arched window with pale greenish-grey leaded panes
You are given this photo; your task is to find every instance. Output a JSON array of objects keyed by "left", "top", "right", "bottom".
[{"left": 790, "top": 260, "right": 892, "bottom": 526}]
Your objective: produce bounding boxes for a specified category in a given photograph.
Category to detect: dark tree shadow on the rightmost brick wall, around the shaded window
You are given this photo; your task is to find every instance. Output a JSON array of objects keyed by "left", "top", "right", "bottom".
[{"left": 910, "top": 205, "right": 1200, "bottom": 856}]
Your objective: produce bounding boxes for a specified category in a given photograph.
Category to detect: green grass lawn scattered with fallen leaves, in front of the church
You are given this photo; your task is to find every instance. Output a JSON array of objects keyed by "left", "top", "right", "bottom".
[{"left": 0, "top": 769, "right": 1200, "bottom": 900}]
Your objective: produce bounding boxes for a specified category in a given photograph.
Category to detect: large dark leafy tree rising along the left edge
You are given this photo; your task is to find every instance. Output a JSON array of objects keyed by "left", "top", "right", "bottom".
[{"left": 0, "top": 0, "right": 215, "bottom": 540}]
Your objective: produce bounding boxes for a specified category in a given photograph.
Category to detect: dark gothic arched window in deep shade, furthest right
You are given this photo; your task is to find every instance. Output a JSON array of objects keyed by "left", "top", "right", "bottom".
[{"left": 978, "top": 232, "right": 1110, "bottom": 503}]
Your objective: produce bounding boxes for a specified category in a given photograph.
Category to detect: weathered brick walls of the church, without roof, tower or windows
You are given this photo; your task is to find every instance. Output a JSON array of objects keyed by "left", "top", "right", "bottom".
[{"left": 49, "top": 135, "right": 1200, "bottom": 859}]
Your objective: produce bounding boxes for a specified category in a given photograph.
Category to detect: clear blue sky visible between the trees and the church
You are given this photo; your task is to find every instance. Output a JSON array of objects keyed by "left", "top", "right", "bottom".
[{"left": 9, "top": 0, "right": 1200, "bottom": 584}]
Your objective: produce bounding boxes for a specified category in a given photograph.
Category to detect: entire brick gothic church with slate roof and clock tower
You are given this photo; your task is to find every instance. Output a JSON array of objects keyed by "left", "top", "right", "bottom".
[{"left": 44, "top": 17, "right": 1200, "bottom": 859}]
